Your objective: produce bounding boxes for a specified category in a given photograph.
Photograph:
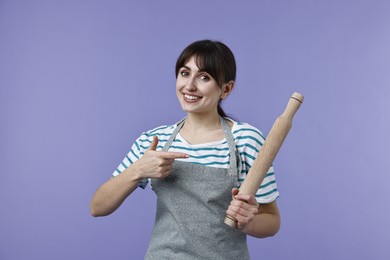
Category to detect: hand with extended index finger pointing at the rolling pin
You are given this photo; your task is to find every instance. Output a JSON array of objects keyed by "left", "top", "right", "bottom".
[{"left": 133, "top": 136, "right": 189, "bottom": 179}]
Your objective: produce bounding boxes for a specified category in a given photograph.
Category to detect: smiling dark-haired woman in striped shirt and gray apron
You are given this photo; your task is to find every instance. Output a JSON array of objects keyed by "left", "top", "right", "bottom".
[{"left": 91, "top": 40, "right": 280, "bottom": 259}]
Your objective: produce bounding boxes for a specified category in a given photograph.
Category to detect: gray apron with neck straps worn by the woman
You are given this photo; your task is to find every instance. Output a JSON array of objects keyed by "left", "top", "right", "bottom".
[{"left": 145, "top": 117, "right": 249, "bottom": 260}]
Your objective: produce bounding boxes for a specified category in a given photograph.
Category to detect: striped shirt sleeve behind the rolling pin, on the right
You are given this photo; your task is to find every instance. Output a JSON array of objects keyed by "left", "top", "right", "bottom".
[{"left": 237, "top": 124, "right": 279, "bottom": 204}]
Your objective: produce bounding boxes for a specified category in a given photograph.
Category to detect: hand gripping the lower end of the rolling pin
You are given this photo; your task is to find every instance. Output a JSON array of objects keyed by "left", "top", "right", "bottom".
[{"left": 226, "top": 188, "right": 259, "bottom": 231}]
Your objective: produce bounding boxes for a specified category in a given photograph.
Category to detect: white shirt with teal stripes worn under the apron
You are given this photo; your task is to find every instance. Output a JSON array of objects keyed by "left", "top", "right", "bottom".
[{"left": 112, "top": 118, "right": 279, "bottom": 203}]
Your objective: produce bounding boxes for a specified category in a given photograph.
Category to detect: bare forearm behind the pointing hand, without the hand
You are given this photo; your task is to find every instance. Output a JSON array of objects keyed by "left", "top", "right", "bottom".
[{"left": 90, "top": 165, "right": 141, "bottom": 217}]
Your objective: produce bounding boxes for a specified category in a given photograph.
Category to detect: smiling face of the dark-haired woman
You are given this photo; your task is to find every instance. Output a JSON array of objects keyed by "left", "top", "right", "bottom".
[{"left": 176, "top": 57, "right": 222, "bottom": 116}]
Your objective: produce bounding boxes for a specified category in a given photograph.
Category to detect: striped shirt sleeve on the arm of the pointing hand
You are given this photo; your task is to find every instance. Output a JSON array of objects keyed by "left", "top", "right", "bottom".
[{"left": 112, "top": 133, "right": 150, "bottom": 189}]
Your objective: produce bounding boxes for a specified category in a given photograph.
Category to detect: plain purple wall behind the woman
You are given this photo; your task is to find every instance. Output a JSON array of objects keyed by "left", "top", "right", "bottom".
[{"left": 0, "top": 0, "right": 390, "bottom": 260}]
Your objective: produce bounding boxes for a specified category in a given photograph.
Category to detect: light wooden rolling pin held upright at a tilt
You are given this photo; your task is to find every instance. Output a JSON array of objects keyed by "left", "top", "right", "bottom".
[{"left": 224, "top": 92, "right": 303, "bottom": 228}]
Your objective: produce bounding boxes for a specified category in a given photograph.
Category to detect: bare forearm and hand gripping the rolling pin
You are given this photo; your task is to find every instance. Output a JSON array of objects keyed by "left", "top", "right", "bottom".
[{"left": 226, "top": 188, "right": 280, "bottom": 238}]
